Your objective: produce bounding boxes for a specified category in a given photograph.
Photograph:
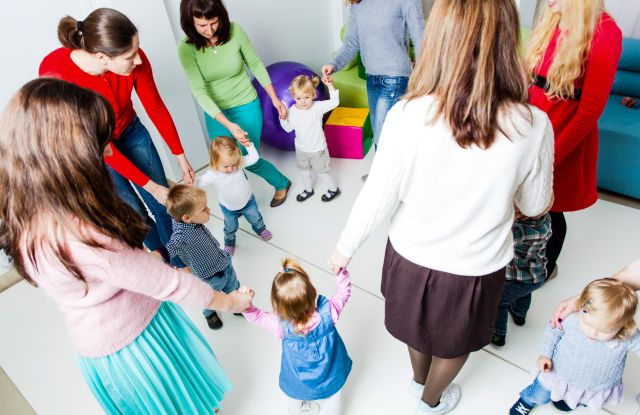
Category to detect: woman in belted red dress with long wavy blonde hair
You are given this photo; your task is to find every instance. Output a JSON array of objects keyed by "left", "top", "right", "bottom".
[{"left": 525, "top": 0, "right": 622, "bottom": 278}]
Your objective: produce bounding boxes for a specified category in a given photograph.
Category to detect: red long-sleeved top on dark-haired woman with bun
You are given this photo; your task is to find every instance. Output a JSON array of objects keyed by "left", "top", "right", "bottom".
[{"left": 39, "top": 48, "right": 184, "bottom": 186}]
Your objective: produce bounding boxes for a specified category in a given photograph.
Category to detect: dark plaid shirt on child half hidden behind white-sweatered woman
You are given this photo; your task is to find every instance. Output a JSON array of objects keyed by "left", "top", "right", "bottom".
[{"left": 507, "top": 213, "right": 551, "bottom": 284}]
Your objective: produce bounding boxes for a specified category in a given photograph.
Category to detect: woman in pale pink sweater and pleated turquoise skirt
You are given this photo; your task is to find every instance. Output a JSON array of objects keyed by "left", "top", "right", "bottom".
[{"left": 0, "top": 78, "right": 250, "bottom": 414}]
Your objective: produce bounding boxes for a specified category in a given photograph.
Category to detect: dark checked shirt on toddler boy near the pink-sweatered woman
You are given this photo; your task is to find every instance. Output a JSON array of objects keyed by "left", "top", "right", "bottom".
[{"left": 167, "top": 219, "right": 229, "bottom": 280}]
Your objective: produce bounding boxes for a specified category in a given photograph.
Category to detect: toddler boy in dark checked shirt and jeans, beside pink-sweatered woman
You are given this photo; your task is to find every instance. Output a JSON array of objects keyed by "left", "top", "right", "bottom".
[{"left": 167, "top": 184, "right": 240, "bottom": 330}]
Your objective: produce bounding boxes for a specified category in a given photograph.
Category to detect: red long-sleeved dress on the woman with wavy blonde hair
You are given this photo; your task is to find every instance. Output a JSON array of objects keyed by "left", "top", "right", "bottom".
[{"left": 529, "top": 13, "right": 622, "bottom": 212}]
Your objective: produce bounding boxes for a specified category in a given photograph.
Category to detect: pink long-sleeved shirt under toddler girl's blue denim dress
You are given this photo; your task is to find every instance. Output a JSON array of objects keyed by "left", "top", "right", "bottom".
[{"left": 242, "top": 270, "right": 351, "bottom": 339}]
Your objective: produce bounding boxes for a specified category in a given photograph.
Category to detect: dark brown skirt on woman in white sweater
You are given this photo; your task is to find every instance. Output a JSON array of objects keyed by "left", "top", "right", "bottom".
[{"left": 381, "top": 241, "right": 505, "bottom": 359}]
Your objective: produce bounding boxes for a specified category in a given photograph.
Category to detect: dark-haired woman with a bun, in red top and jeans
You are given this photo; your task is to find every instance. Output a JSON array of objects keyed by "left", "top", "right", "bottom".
[{"left": 39, "top": 8, "right": 195, "bottom": 267}]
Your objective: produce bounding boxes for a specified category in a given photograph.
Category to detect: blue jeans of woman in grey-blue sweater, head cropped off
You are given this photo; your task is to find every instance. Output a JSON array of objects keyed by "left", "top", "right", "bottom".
[{"left": 367, "top": 75, "right": 409, "bottom": 147}]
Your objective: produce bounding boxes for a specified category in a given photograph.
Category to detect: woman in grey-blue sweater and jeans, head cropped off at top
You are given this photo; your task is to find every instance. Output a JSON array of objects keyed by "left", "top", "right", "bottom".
[{"left": 322, "top": 0, "right": 424, "bottom": 179}]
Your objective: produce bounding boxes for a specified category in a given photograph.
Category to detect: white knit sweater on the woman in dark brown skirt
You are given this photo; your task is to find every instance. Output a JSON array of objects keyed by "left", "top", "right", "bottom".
[{"left": 338, "top": 96, "right": 554, "bottom": 276}]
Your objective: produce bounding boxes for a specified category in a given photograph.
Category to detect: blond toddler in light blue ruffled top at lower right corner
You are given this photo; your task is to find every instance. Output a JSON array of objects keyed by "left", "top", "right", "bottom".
[{"left": 509, "top": 278, "right": 640, "bottom": 415}]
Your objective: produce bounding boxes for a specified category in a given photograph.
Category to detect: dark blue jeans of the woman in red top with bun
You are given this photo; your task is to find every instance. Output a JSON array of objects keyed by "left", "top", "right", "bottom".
[{"left": 107, "top": 116, "right": 185, "bottom": 268}]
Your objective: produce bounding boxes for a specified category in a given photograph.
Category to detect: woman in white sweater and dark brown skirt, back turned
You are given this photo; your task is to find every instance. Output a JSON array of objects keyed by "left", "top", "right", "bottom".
[{"left": 329, "top": 0, "right": 553, "bottom": 414}]
